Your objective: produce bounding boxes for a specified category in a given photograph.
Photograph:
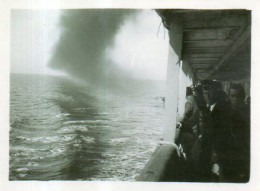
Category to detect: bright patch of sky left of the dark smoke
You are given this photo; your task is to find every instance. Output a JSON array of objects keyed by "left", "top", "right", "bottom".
[{"left": 11, "top": 10, "right": 61, "bottom": 75}]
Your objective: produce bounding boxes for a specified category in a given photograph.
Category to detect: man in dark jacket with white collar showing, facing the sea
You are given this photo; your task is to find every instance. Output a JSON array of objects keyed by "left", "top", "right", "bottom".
[{"left": 196, "top": 80, "right": 231, "bottom": 182}]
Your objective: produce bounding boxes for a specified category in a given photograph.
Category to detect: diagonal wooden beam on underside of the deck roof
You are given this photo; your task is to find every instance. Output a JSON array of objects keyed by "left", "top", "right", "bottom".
[{"left": 208, "top": 25, "right": 251, "bottom": 78}]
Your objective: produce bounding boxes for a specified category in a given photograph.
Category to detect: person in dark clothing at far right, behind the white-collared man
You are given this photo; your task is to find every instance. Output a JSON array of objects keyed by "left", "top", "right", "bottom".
[{"left": 224, "top": 84, "right": 250, "bottom": 182}]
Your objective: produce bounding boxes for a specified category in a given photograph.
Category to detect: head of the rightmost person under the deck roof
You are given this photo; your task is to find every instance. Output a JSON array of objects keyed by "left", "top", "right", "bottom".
[{"left": 229, "top": 84, "right": 245, "bottom": 108}]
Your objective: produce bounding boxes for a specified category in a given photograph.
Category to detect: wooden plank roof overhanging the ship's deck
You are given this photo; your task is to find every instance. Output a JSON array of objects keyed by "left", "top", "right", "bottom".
[{"left": 156, "top": 9, "right": 251, "bottom": 80}]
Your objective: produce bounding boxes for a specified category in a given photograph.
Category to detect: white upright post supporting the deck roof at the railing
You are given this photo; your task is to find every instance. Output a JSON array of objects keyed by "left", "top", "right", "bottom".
[{"left": 164, "top": 16, "right": 183, "bottom": 142}]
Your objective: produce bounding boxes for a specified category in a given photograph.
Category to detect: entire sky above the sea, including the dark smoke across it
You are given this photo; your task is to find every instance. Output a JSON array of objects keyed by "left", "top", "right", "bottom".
[{"left": 11, "top": 10, "right": 169, "bottom": 80}]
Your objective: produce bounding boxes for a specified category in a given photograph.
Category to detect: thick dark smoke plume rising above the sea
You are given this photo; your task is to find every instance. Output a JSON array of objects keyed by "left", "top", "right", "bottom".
[{"left": 49, "top": 9, "right": 137, "bottom": 89}]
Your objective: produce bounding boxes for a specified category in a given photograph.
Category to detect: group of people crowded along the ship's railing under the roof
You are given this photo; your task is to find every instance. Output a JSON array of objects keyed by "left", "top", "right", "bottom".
[{"left": 177, "top": 80, "right": 250, "bottom": 182}]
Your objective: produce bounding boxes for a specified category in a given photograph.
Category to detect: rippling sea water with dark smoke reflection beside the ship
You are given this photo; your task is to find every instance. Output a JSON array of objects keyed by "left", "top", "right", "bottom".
[{"left": 9, "top": 74, "right": 165, "bottom": 181}]
